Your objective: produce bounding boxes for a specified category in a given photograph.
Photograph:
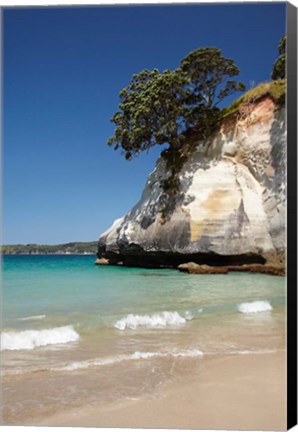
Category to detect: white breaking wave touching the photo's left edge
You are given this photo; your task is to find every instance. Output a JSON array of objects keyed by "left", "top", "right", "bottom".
[{"left": 1, "top": 326, "right": 80, "bottom": 351}]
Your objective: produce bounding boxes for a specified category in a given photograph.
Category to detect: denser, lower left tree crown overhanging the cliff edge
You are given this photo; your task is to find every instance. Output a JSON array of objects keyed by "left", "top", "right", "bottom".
[{"left": 108, "top": 69, "right": 186, "bottom": 159}]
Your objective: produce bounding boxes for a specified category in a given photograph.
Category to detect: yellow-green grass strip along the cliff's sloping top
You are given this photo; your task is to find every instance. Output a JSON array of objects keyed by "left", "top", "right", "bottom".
[{"left": 220, "top": 79, "right": 286, "bottom": 120}]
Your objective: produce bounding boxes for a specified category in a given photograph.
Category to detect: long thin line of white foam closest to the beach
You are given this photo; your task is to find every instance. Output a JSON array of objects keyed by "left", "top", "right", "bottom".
[{"left": 51, "top": 349, "right": 204, "bottom": 372}]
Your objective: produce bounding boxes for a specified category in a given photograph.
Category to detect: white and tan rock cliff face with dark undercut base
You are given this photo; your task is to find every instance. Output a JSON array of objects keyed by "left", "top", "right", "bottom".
[{"left": 98, "top": 97, "right": 286, "bottom": 267}]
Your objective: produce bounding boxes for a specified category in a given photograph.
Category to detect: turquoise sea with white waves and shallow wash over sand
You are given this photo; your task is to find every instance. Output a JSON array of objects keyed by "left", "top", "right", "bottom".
[{"left": 1, "top": 255, "right": 285, "bottom": 424}]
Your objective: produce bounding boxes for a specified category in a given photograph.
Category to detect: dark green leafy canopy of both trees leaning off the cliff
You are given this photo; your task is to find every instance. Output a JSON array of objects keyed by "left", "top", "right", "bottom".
[{"left": 108, "top": 48, "right": 245, "bottom": 159}]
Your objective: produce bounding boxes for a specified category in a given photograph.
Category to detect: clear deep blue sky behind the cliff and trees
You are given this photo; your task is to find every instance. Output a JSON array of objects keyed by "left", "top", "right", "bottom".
[{"left": 3, "top": 3, "right": 286, "bottom": 244}]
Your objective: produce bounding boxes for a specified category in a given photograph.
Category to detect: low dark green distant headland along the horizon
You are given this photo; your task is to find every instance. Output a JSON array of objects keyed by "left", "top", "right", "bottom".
[{"left": 1, "top": 241, "right": 97, "bottom": 255}]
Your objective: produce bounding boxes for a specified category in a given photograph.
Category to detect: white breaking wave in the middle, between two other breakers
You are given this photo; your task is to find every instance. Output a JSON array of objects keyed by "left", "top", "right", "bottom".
[{"left": 114, "top": 312, "right": 191, "bottom": 330}]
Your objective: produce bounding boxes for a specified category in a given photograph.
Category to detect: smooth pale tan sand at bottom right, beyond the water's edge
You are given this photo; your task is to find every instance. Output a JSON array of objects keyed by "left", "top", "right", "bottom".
[{"left": 36, "top": 350, "right": 286, "bottom": 430}]
